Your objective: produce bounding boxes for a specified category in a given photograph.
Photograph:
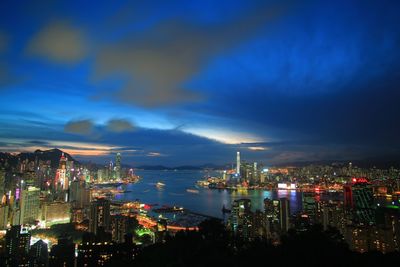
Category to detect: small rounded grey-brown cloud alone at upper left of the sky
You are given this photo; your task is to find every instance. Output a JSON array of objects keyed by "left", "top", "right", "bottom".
[{"left": 27, "top": 21, "right": 88, "bottom": 63}]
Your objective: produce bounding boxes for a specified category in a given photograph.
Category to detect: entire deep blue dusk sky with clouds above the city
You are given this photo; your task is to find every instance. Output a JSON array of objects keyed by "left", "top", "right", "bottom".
[{"left": 0, "top": 0, "right": 400, "bottom": 166}]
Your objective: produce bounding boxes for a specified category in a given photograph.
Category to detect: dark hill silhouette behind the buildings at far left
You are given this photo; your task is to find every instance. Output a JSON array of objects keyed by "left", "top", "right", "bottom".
[{"left": 0, "top": 148, "right": 76, "bottom": 168}]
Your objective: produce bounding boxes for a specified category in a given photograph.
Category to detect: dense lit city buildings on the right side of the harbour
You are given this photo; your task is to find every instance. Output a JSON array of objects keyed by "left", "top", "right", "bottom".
[{"left": 227, "top": 153, "right": 400, "bottom": 253}]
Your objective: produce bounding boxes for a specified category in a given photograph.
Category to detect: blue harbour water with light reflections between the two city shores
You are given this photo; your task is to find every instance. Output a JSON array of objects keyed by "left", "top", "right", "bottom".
[{"left": 116, "top": 171, "right": 301, "bottom": 218}]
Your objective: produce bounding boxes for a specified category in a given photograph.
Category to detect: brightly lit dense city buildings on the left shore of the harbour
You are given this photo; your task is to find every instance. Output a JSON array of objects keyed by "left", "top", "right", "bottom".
[{"left": 0, "top": 153, "right": 144, "bottom": 266}]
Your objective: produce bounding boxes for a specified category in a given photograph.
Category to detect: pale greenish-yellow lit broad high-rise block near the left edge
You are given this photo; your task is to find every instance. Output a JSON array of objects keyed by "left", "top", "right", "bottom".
[{"left": 19, "top": 186, "right": 40, "bottom": 225}]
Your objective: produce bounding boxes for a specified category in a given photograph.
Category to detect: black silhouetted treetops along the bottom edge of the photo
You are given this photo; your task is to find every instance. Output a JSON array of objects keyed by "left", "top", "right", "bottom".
[{"left": 134, "top": 220, "right": 400, "bottom": 267}]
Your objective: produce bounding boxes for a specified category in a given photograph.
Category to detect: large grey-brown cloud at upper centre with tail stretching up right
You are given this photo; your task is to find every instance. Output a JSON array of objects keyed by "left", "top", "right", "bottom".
[{"left": 94, "top": 2, "right": 294, "bottom": 107}]
